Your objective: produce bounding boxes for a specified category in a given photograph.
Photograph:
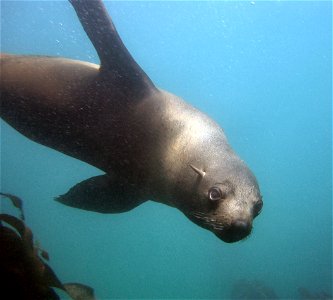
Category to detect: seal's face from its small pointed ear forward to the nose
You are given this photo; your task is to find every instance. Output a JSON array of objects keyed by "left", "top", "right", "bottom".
[{"left": 182, "top": 155, "right": 263, "bottom": 243}]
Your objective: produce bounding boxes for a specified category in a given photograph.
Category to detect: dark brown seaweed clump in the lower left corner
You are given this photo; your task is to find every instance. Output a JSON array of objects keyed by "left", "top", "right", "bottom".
[{"left": 0, "top": 193, "right": 95, "bottom": 300}]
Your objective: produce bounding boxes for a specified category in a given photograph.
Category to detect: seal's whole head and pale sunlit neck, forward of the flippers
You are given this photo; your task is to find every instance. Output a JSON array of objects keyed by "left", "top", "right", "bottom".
[{"left": 152, "top": 98, "right": 263, "bottom": 243}]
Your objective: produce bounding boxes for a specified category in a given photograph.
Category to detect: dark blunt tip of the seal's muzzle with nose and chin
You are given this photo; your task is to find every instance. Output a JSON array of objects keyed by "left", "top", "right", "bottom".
[{"left": 213, "top": 220, "right": 252, "bottom": 243}]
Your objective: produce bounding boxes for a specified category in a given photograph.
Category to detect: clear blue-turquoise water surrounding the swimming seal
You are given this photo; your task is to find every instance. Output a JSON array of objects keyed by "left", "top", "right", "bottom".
[{"left": 1, "top": 1, "right": 332, "bottom": 299}]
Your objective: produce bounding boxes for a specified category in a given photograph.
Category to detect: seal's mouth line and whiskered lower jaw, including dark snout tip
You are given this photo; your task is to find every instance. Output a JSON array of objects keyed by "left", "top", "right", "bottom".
[{"left": 185, "top": 212, "right": 252, "bottom": 243}]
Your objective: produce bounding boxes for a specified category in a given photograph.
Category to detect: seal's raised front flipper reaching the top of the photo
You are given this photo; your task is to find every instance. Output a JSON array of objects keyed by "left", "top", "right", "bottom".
[{"left": 69, "top": 0, "right": 156, "bottom": 95}]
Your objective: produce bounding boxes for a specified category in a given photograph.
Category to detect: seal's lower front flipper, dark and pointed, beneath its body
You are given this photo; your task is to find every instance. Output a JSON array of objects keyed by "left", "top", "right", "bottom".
[{"left": 55, "top": 175, "right": 146, "bottom": 213}]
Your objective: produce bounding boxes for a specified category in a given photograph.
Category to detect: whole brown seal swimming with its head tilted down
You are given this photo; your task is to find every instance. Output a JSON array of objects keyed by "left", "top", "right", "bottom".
[{"left": 0, "top": 0, "right": 263, "bottom": 243}]
